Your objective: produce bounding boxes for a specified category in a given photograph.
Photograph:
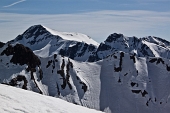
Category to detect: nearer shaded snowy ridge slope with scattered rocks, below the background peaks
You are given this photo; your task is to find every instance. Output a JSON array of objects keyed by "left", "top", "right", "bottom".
[{"left": 0, "top": 42, "right": 170, "bottom": 113}]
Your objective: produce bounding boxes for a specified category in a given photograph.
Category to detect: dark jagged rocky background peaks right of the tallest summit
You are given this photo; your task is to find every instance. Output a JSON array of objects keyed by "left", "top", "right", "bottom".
[{"left": 89, "top": 33, "right": 170, "bottom": 62}]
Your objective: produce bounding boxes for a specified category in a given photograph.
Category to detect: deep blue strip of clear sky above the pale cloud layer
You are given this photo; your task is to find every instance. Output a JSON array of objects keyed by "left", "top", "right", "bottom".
[{"left": 0, "top": 0, "right": 170, "bottom": 14}]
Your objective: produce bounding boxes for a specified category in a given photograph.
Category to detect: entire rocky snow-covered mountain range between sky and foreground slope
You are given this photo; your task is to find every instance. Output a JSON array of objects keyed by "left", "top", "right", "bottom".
[{"left": 0, "top": 25, "right": 170, "bottom": 113}]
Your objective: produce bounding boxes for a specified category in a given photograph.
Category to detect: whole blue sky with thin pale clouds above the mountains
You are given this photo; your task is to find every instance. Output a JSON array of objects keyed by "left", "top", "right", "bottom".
[{"left": 0, "top": 0, "right": 170, "bottom": 42}]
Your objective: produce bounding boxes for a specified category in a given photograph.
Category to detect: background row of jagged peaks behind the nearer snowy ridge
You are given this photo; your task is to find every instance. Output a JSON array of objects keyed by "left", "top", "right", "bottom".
[{"left": 8, "top": 25, "right": 170, "bottom": 62}]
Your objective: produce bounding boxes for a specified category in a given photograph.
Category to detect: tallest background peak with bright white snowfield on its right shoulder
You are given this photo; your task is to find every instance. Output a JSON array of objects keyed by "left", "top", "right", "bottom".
[{"left": 8, "top": 25, "right": 98, "bottom": 61}]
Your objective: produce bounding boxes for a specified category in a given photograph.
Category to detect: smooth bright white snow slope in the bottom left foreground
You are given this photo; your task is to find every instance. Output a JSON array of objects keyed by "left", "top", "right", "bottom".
[{"left": 0, "top": 84, "right": 102, "bottom": 113}]
